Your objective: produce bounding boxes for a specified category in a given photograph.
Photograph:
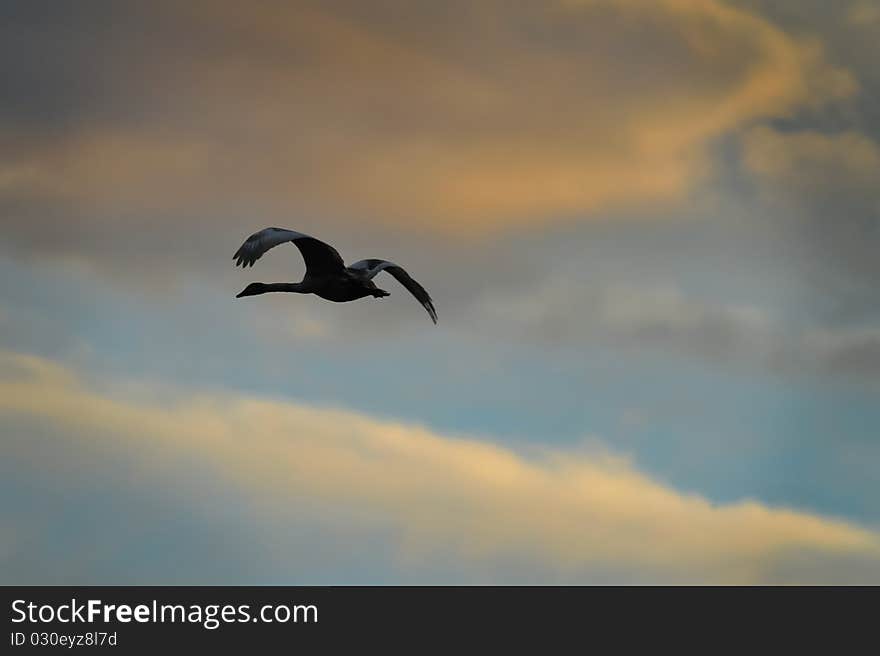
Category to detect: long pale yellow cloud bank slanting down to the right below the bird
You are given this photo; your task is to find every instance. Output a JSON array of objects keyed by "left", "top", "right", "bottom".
[{"left": 0, "top": 353, "right": 880, "bottom": 583}]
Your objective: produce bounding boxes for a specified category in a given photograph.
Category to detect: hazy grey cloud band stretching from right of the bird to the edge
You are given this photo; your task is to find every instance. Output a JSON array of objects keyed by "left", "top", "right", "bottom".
[{"left": 471, "top": 271, "right": 880, "bottom": 380}]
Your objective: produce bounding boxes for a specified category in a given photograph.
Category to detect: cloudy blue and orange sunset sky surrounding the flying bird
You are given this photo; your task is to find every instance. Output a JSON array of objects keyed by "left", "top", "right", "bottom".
[{"left": 0, "top": 0, "right": 880, "bottom": 585}]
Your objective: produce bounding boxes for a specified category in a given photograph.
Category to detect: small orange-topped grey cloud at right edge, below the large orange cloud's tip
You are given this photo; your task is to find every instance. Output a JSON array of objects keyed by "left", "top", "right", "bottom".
[{"left": 743, "top": 127, "right": 880, "bottom": 312}]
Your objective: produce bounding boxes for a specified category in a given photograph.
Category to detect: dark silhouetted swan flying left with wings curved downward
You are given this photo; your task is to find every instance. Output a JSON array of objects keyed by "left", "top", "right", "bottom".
[{"left": 233, "top": 228, "right": 437, "bottom": 323}]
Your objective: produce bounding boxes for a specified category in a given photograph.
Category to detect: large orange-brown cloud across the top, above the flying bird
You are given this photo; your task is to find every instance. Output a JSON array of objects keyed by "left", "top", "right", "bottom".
[{"left": 0, "top": 0, "right": 855, "bottom": 268}]
